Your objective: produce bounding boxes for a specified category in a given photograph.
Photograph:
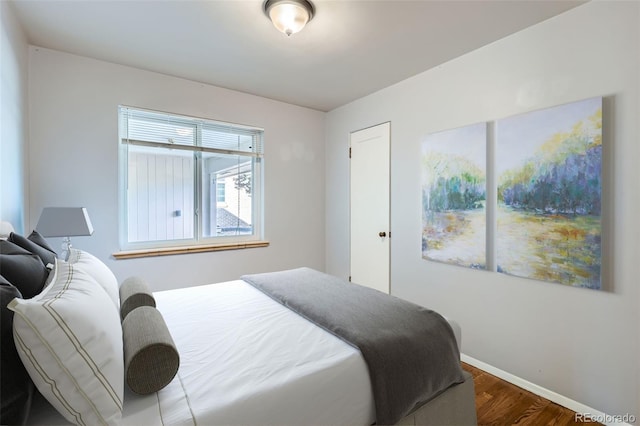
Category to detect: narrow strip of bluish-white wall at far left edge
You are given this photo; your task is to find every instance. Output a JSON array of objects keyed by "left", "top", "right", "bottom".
[{"left": 0, "top": 1, "right": 28, "bottom": 232}]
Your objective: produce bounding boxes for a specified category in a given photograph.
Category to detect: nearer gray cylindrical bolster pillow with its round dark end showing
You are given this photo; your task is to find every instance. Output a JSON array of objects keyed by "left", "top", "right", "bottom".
[{"left": 122, "top": 306, "right": 180, "bottom": 395}]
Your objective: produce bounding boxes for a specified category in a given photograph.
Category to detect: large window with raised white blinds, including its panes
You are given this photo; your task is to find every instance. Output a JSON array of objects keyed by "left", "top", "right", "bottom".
[{"left": 119, "top": 107, "right": 263, "bottom": 250}]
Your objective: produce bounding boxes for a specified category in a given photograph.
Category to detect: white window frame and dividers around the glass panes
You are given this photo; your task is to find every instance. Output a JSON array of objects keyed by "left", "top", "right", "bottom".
[{"left": 114, "top": 105, "right": 268, "bottom": 258}]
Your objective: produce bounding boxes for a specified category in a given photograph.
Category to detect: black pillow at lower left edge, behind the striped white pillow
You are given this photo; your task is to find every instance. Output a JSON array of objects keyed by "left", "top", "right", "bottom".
[{"left": 0, "top": 275, "right": 34, "bottom": 425}]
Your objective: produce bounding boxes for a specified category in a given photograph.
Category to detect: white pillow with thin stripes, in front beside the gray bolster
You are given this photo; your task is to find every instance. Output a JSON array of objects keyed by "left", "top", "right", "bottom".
[{"left": 8, "top": 260, "right": 124, "bottom": 425}]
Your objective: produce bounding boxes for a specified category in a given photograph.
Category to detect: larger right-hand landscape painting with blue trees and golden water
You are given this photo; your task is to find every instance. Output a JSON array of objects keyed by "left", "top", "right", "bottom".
[{"left": 496, "top": 97, "right": 602, "bottom": 289}]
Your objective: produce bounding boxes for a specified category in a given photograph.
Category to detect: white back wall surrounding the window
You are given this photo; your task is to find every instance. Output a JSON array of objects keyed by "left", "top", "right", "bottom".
[{"left": 26, "top": 47, "right": 325, "bottom": 290}]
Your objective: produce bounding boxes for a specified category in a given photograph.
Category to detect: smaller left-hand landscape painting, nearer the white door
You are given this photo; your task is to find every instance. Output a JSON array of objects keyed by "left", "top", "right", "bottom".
[{"left": 421, "top": 123, "right": 487, "bottom": 269}]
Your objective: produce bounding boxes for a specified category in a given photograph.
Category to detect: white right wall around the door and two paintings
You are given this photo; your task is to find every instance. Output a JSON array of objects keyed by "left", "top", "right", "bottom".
[{"left": 326, "top": 2, "right": 640, "bottom": 417}]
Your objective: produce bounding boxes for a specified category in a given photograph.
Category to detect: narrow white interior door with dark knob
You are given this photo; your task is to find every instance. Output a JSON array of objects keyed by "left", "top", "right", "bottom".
[{"left": 349, "top": 123, "right": 391, "bottom": 293}]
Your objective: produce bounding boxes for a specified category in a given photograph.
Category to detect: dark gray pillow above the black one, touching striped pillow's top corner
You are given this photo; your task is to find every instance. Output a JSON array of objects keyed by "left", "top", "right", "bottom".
[{"left": 0, "top": 240, "right": 49, "bottom": 299}]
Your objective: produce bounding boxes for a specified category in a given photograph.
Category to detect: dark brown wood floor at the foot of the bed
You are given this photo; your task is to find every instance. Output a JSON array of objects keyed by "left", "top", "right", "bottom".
[{"left": 462, "top": 363, "right": 598, "bottom": 426}]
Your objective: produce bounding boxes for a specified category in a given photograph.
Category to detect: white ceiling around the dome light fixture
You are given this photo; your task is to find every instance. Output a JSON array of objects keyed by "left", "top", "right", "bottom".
[{"left": 10, "top": 0, "right": 584, "bottom": 111}]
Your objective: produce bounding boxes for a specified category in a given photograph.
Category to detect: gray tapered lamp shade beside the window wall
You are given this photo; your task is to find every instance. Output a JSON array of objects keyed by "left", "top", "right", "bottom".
[{"left": 36, "top": 207, "right": 93, "bottom": 237}]
